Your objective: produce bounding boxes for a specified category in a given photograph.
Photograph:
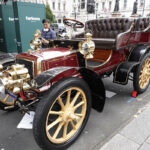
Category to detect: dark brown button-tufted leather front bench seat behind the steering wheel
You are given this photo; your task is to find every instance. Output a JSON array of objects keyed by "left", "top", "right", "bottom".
[{"left": 75, "top": 18, "right": 133, "bottom": 50}]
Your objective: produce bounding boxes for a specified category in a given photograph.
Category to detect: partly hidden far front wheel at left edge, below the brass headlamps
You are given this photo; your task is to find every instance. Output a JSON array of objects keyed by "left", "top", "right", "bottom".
[{"left": 0, "top": 94, "right": 17, "bottom": 111}]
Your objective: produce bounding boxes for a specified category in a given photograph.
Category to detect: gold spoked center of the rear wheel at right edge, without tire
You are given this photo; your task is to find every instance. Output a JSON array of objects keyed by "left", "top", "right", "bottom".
[{"left": 139, "top": 58, "right": 150, "bottom": 89}]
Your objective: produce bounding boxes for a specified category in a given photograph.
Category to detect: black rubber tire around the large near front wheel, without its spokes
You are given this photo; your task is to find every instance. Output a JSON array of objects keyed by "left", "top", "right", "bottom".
[{"left": 33, "top": 78, "right": 91, "bottom": 150}]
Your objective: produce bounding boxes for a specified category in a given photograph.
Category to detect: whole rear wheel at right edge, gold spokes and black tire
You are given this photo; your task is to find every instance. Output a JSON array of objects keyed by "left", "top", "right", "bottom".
[{"left": 133, "top": 54, "right": 150, "bottom": 94}]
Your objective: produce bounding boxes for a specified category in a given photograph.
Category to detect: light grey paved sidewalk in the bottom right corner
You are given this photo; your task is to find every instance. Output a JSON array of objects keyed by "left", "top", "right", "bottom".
[{"left": 99, "top": 103, "right": 150, "bottom": 150}]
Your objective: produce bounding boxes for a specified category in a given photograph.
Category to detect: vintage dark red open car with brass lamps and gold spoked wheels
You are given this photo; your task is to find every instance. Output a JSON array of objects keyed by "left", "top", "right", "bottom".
[{"left": 0, "top": 18, "right": 150, "bottom": 150}]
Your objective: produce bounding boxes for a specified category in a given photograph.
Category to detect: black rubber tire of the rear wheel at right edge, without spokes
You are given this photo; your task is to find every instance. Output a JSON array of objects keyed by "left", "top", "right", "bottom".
[{"left": 133, "top": 53, "right": 150, "bottom": 94}]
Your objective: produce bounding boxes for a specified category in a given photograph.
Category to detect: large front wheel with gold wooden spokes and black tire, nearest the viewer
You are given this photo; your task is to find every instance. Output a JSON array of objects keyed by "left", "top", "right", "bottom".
[{"left": 33, "top": 78, "right": 91, "bottom": 150}]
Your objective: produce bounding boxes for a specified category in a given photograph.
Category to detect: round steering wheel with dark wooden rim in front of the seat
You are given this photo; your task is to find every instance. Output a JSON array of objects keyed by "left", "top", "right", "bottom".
[{"left": 63, "top": 18, "right": 84, "bottom": 28}]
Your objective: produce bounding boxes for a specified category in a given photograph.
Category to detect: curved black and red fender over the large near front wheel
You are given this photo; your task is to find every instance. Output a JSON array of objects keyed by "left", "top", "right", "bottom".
[{"left": 34, "top": 67, "right": 106, "bottom": 112}]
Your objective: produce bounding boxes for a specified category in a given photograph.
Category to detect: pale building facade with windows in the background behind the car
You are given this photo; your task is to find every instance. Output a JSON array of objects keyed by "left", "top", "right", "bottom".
[{"left": 47, "top": 0, "right": 150, "bottom": 23}]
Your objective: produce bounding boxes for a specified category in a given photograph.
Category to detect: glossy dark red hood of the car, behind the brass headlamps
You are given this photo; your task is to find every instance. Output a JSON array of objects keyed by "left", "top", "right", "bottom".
[{"left": 16, "top": 48, "right": 79, "bottom": 77}]
